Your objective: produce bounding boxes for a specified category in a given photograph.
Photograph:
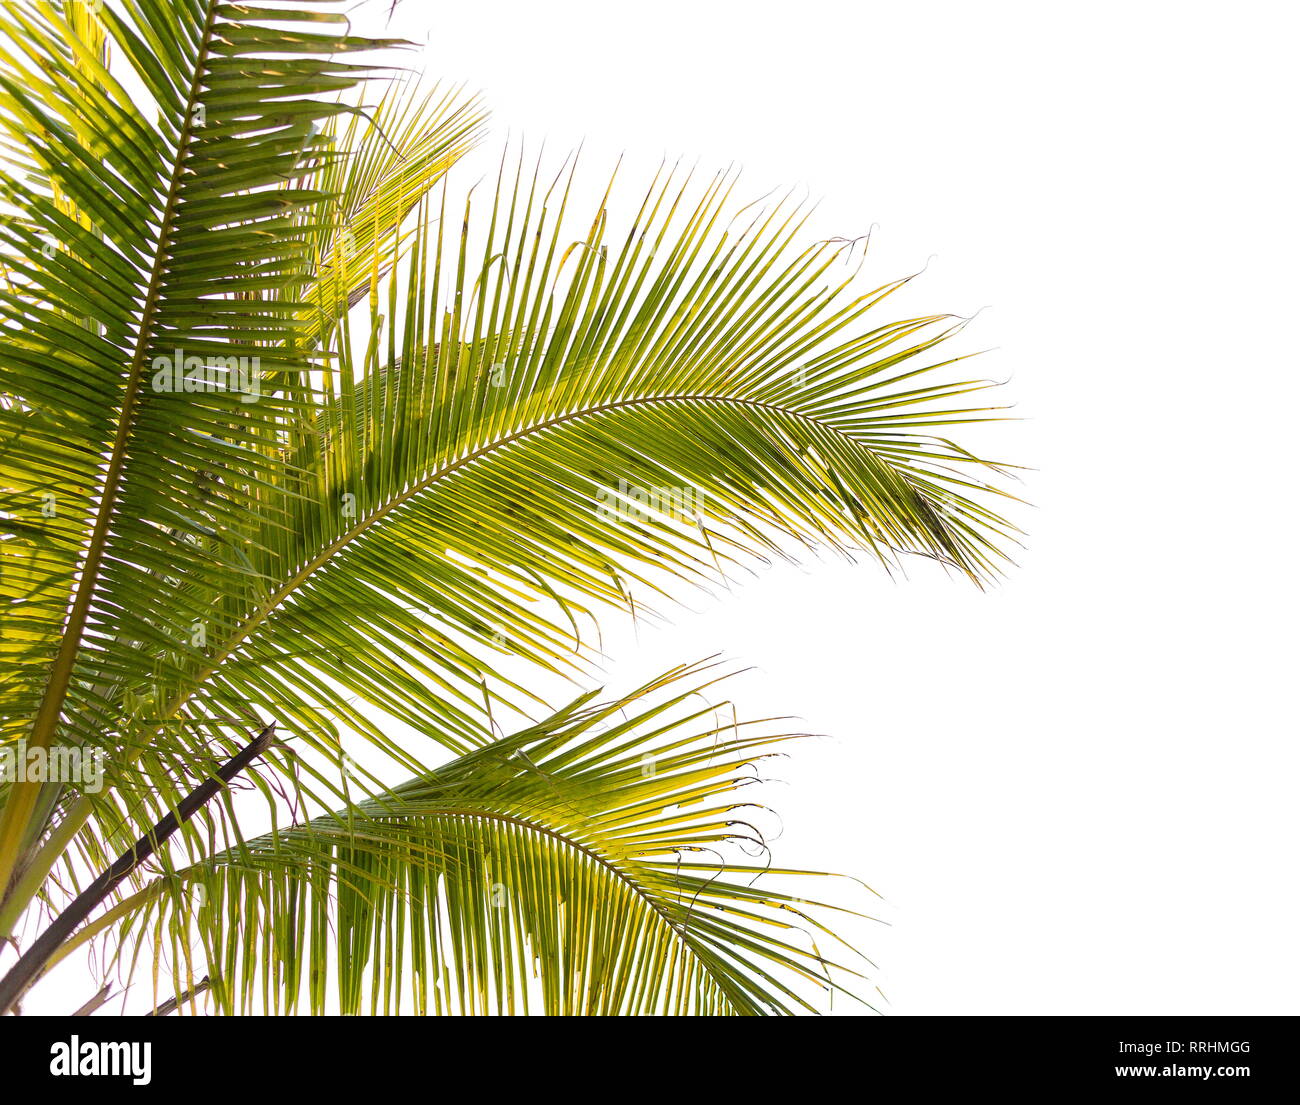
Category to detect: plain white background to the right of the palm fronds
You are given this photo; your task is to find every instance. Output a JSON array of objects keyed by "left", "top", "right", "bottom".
[{"left": 379, "top": 0, "right": 1300, "bottom": 1014}]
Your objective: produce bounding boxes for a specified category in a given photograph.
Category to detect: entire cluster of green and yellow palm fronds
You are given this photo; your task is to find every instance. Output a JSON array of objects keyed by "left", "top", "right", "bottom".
[{"left": 0, "top": 0, "right": 1011, "bottom": 1013}]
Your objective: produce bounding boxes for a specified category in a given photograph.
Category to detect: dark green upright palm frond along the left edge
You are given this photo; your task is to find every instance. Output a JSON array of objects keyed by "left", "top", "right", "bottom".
[{"left": 0, "top": 0, "right": 400, "bottom": 885}]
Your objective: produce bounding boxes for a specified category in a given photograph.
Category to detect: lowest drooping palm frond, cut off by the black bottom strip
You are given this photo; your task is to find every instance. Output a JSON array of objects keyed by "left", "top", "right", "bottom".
[{"left": 101, "top": 668, "right": 867, "bottom": 1015}]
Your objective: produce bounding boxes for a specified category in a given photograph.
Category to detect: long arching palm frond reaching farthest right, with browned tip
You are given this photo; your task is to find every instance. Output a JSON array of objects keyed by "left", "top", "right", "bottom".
[{"left": 172, "top": 154, "right": 1011, "bottom": 785}]
